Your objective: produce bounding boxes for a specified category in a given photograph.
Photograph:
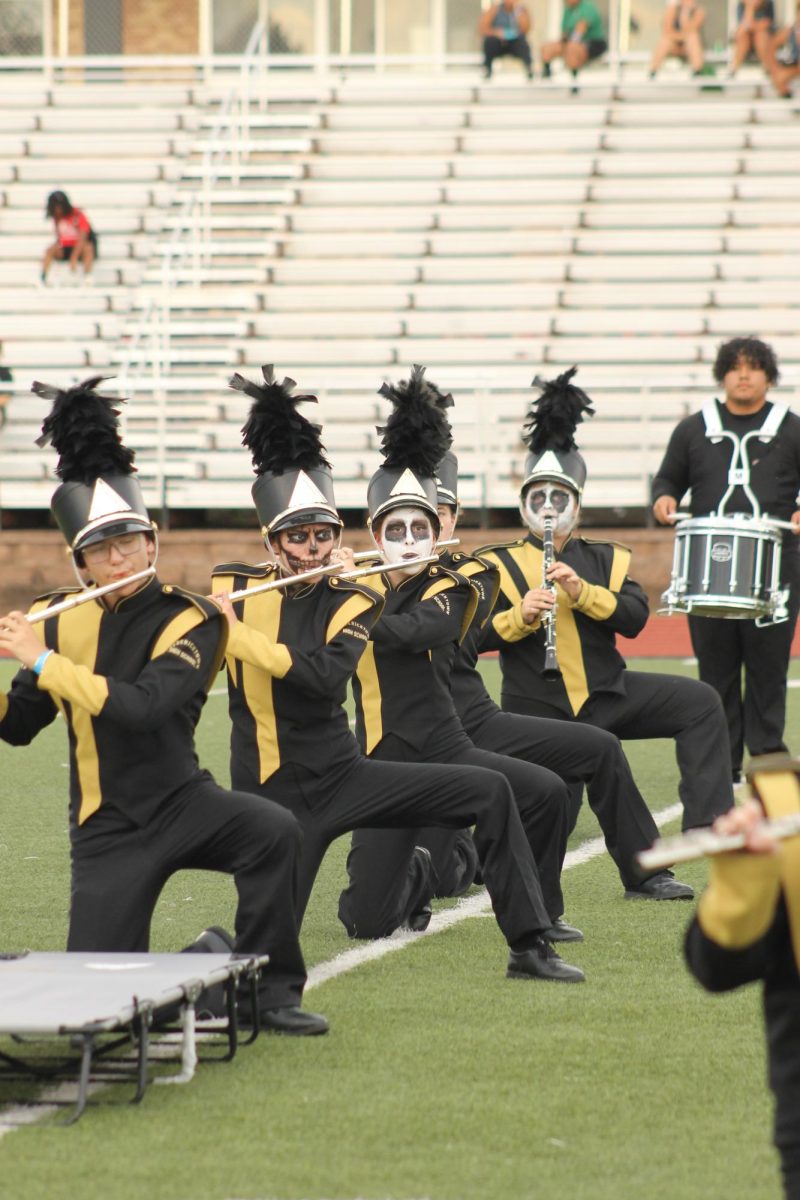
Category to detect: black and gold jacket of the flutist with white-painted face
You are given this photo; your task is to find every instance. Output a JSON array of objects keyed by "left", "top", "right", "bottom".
[{"left": 353, "top": 564, "right": 477, "bottom": 754}]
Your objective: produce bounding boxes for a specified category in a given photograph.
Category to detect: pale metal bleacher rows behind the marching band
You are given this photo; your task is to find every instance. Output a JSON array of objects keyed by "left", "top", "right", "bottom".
[{"left": 0, "top": 64, "right": 800, "bottom": 510}]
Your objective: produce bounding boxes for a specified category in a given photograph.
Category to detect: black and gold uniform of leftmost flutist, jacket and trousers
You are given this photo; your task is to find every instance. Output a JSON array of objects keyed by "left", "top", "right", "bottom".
[{"left": 0, "top": 578, "right": 306, "bottom": 1009}]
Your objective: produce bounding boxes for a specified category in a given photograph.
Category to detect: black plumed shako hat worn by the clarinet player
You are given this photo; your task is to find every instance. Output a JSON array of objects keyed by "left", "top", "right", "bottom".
[{"left": 519, "top": 367, "right": 595, "bottom": 498}]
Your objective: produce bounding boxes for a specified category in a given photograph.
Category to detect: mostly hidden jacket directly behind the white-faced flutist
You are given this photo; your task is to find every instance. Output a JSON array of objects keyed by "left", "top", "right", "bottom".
[{"left": 441, "top": 551, "right": 500, "bottom": 733}]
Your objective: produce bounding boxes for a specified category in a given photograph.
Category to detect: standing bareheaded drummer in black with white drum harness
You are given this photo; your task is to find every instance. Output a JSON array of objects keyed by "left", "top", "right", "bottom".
[{"left": 652, "top": 337, "right": 800, "bottom": 781}]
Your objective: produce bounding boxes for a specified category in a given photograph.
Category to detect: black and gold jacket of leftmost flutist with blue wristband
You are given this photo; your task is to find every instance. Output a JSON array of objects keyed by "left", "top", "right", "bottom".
[{"left": 0, "top": 578, "right": 227, "bottom": 828}]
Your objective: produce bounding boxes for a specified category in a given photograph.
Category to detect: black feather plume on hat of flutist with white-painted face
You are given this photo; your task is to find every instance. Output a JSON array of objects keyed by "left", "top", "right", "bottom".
[{"left": 378, "top": 366, "right": 453, "bottom": 478}]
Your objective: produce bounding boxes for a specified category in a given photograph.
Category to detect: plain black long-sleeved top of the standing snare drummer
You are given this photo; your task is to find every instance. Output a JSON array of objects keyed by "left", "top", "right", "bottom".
[{"left": 652, "top": 401, "right": 800, "bottom": 537}]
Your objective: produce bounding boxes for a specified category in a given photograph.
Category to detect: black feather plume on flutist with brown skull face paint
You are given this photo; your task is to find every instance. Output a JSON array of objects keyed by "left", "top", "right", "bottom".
[{"left": 228, "top": 364, "right": 330, "bottom": 475}]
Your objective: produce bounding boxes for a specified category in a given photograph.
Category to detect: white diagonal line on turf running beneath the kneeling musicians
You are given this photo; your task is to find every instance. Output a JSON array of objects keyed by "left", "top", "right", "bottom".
[{"left": 0, "top": 806, "right": 681, "bottom": 1139}]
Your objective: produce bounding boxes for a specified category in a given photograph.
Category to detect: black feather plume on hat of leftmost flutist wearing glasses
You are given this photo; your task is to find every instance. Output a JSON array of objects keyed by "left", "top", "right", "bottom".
[{"left": 31, "top": 376, "right": 136, "bottom": 485}]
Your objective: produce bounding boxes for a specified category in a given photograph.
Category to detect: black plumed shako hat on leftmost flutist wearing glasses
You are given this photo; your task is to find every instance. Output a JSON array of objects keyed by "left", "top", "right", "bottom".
[{"left": 31, "top": 376, "right": 155, "bottom": 553}]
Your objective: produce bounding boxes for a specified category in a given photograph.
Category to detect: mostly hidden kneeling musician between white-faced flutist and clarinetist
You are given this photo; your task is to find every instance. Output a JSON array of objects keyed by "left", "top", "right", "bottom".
[{"left": 429, "top": 451, "right": 686, "bottom": 899}]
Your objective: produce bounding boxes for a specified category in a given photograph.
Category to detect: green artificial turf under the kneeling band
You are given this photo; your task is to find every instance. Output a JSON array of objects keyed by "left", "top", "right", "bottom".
[{"left": 0, "top": 661, "right": 798, "bottom": 1200}]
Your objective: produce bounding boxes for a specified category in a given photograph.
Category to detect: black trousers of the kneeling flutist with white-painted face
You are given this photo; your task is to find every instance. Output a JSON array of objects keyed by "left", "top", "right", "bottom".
[{"left": 339, "top": 733, "right": 569, "bottom": 937}]
